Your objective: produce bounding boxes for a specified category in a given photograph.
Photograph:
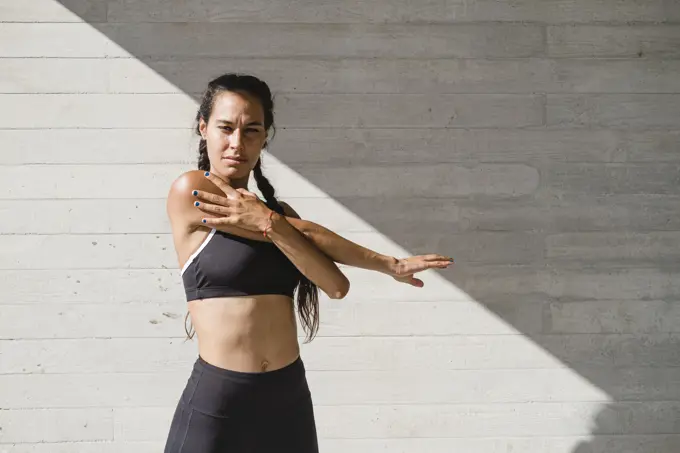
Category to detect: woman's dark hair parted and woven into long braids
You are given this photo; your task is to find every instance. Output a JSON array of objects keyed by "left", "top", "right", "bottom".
[{"left": 190, "top": 73, "right": 319, "bottom": 342}]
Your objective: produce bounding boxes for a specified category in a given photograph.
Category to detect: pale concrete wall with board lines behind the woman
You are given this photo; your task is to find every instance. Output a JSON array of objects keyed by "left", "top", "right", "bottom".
[{"left": 0, "top": 0, "right": 680, "bottom": 453}]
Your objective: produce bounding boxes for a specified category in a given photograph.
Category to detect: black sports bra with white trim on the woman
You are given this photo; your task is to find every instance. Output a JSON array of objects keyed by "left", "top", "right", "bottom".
[{"left": 181, "top": 228, "right": 302, "bottom": 302}]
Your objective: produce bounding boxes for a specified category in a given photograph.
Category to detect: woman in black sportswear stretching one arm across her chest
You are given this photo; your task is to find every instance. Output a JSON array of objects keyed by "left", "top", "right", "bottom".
[{"left": 165, "top": 74, "right": 451, "bottom": 453}]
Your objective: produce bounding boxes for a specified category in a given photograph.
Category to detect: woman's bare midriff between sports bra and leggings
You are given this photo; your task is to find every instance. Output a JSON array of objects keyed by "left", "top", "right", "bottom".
[{"left": 189, "top": 295, "right": 300, "bottom": 372}]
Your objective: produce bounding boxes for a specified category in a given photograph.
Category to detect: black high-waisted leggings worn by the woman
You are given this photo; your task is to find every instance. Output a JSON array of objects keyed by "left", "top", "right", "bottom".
[{"left": 165, "top": 356, "right": 319, "bottom": 453}]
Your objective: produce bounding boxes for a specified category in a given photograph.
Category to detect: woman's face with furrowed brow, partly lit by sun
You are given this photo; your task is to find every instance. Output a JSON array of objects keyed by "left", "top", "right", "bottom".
[{"left": 199, "top": 91, "right": 267, "bottom": 179}]
